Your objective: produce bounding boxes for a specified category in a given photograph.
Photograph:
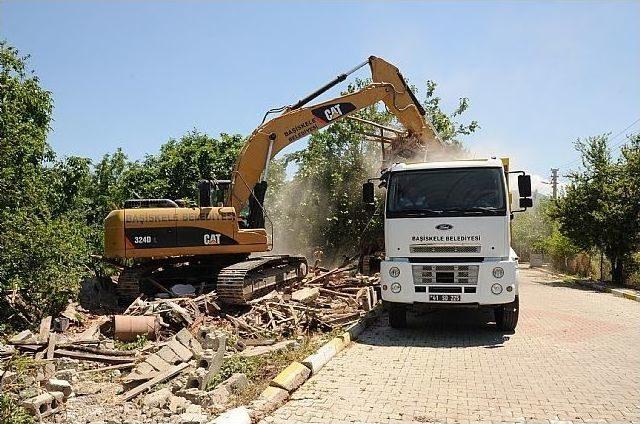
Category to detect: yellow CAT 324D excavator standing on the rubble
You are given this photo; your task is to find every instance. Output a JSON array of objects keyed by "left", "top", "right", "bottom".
[{"left": 103, "top": 56, "right": 441, "bottom": 305}]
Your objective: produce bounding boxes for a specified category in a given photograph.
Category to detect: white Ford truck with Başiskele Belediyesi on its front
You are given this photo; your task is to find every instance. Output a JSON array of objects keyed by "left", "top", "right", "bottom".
[{"left": 363, "top": 158, "right": 533, "bottom": 331}]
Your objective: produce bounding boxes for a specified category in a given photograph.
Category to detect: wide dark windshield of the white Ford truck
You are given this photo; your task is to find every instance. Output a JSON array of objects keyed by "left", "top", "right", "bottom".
[{"left": 387, "top": 168, "right": 507, "bottom": 218}]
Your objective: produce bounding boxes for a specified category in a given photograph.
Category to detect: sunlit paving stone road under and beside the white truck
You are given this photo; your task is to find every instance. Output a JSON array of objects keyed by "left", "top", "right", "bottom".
[{"left": 263, "top": 268, "right": 640, "bottom": 424}]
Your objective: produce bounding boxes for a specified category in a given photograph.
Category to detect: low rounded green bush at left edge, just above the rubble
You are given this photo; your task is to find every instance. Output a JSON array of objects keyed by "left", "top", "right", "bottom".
[{"left": 0, "top": 211, "right": 90, "bottom": 328}]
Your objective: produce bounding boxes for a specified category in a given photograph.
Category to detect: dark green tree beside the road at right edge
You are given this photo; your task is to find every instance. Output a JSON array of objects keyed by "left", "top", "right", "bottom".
[{"left": 552, "top": 134, "right": 640, "bottom": 284}]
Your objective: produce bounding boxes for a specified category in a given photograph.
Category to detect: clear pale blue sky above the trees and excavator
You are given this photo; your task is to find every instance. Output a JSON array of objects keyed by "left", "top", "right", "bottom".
[{"left": 0, "top": 0, "right": 640, "bottom": 191}]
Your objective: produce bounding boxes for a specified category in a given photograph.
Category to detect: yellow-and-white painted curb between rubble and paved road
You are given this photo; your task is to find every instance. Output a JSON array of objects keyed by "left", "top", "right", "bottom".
[{"left": 214, "top": 302, "right": 382, "bottom": 424}]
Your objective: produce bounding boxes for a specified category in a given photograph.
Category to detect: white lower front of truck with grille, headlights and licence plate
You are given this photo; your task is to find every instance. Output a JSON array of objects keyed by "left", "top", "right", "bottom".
[{"left": 380, "top": 260, "right": 518, "bottom": 307}]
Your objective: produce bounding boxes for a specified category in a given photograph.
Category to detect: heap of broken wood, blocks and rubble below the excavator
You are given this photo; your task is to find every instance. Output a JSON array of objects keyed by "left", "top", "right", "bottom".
[{"left": 0, "top": 268, "right": 378, "bottom": 423}]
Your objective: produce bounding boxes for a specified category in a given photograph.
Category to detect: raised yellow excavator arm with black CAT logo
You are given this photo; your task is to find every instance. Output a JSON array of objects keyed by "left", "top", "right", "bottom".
[{"left": 227, "top": 56, "right": 441, "bottom": 220}]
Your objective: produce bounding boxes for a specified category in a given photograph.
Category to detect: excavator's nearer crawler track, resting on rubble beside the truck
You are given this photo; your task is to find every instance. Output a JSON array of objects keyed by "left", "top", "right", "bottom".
[{"left": 216, "top": 255, "right": 308, "bottom": 305}]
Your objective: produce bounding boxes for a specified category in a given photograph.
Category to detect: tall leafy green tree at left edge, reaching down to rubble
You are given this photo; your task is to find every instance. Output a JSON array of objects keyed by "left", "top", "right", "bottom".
[{"left": 0, "top": 42, "right": 89, "bottom": 326}]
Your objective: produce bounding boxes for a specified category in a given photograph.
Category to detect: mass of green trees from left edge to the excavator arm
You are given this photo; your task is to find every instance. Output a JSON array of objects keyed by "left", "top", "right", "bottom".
[{"left": 0, "top": 42, "right": 243, "bottom": 327}]
